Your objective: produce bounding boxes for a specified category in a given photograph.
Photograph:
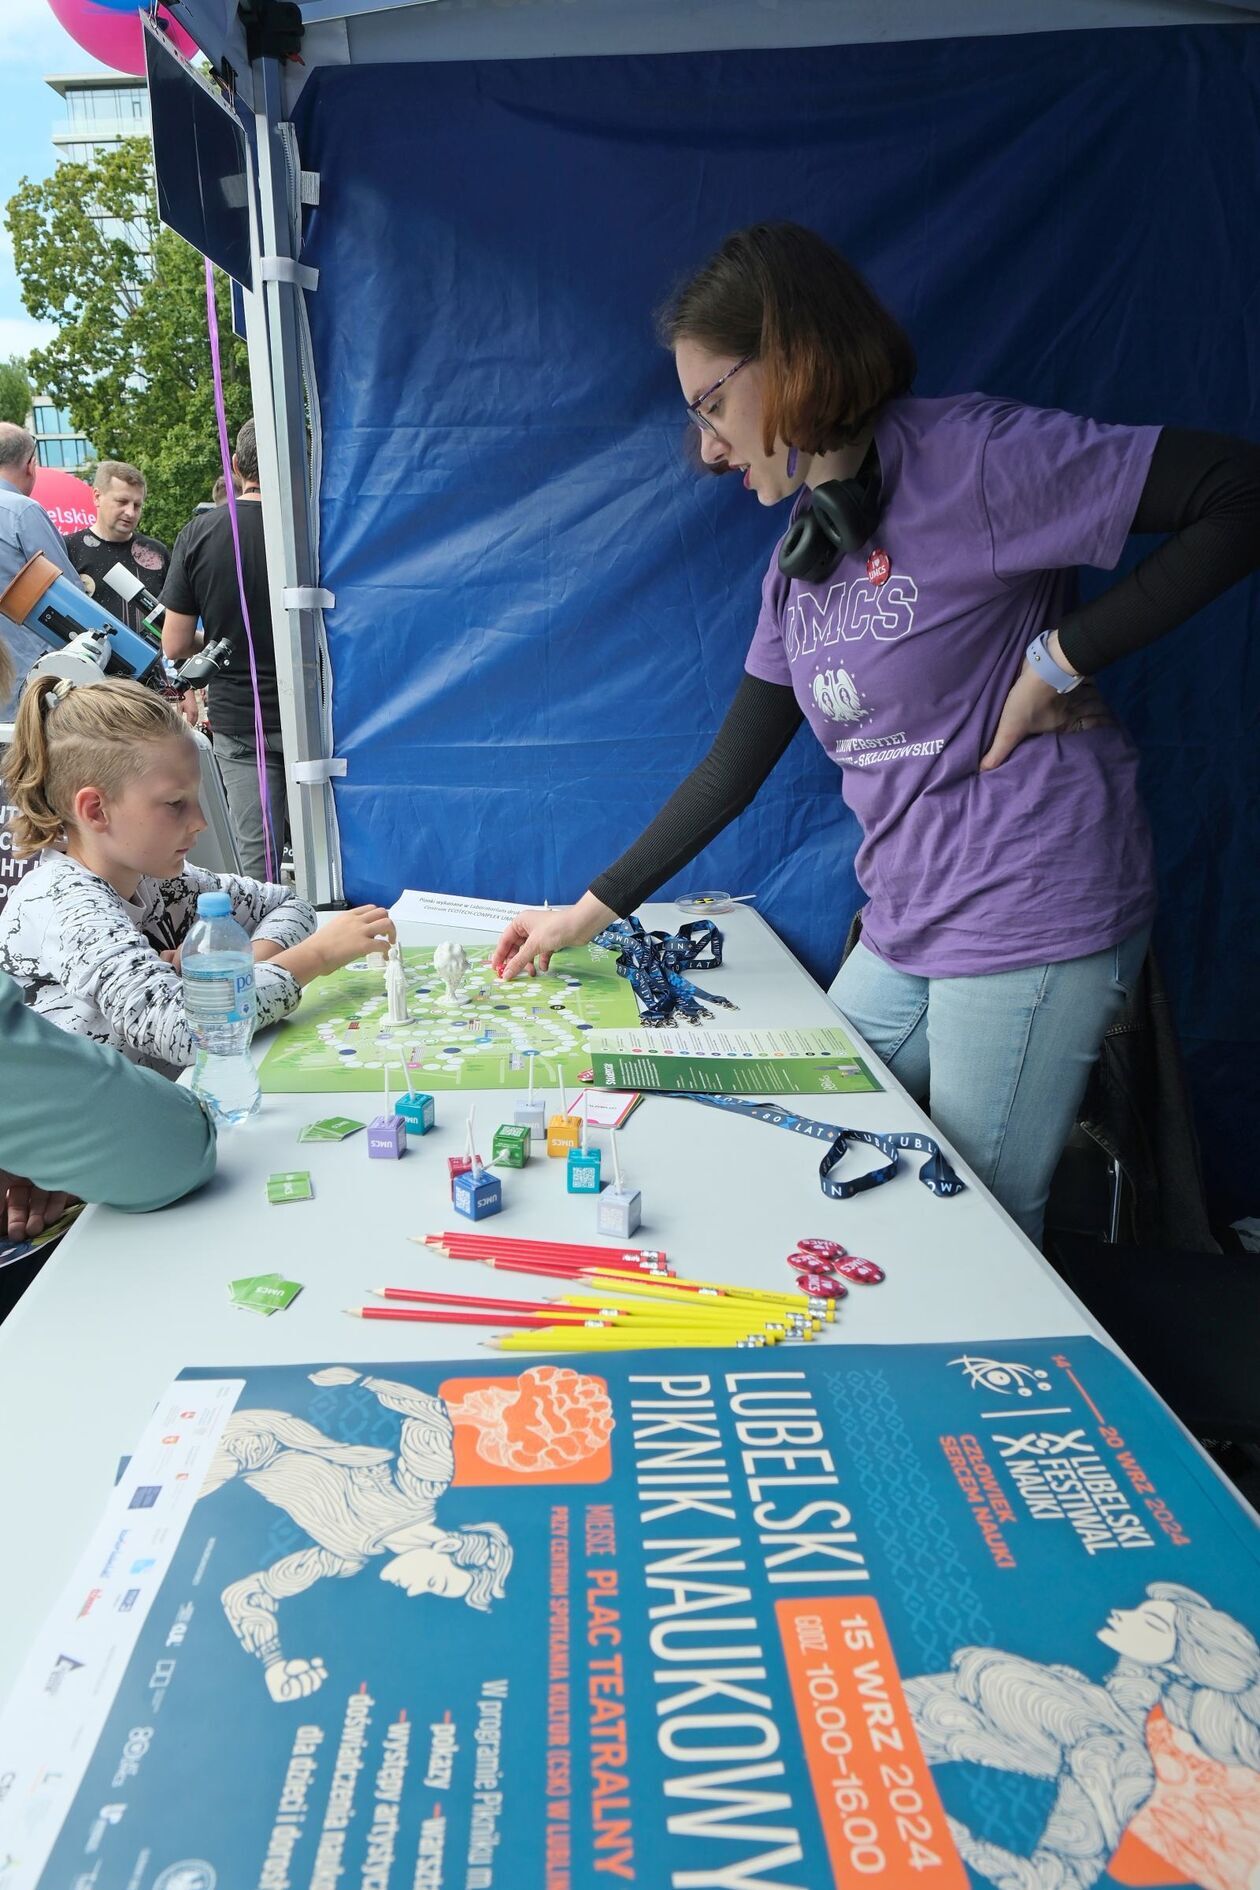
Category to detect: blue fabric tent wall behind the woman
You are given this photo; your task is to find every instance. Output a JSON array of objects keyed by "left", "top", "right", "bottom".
[{"left": 297, "top": 26, "right": 1260, "bottom": 1213}]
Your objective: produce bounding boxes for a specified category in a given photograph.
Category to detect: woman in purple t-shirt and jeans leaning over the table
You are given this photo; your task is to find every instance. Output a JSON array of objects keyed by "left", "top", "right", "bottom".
[{"left": 495, "top": 223, "right": 1260, "bottom": 1240}]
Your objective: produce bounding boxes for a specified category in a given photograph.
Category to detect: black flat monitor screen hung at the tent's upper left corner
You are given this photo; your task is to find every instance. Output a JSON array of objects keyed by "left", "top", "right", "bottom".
[{"left": 144, "top": 23, "right": 253, "bottom": 289}]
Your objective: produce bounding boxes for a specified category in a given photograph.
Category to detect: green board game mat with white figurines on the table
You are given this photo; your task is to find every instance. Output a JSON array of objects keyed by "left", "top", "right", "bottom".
[{"left": 259, "top": 945, "right": 639, "bottom": 1098}]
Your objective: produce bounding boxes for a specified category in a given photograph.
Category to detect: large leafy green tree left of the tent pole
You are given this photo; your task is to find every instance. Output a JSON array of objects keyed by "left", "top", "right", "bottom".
[{"left": 6, "top": 138, "right": 251, "bottom": 542}]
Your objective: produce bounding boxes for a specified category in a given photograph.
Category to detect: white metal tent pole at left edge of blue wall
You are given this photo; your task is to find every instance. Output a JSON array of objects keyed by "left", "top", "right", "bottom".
[{"left": 244, "top": 59, "right": 344, "bottom": 907}]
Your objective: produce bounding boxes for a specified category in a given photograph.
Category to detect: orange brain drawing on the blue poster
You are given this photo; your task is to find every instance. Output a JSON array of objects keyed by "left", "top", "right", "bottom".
[{"left": 450, "top": 1365, "right": 612, "bottom": 1474}]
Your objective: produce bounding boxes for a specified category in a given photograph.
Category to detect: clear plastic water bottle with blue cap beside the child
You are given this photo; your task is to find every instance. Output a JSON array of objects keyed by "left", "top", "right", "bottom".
[{"left": 179, "top": 892, "right": 259, "bottom": 1123}]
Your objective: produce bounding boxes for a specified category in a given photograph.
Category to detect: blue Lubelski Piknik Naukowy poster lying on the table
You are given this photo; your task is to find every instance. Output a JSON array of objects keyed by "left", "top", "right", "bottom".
[{"left": 0, "top": 1338, "right": 1260, "bottom": 1890}]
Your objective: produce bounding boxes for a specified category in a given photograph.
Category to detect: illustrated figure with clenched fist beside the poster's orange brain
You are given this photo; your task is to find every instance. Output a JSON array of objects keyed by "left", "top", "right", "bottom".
[{"left": 198, "top": 1365, "right": 512, "bottom": 1703}]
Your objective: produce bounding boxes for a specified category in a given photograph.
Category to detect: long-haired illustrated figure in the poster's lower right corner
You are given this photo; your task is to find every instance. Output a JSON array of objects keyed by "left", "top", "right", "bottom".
[{"left": 905, "top": 1582, "right": 1260, "bottom": 1890}]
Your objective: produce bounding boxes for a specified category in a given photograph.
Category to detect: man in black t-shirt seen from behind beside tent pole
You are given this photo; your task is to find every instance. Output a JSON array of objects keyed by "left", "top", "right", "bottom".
[{"left": 162, "top": 420, "right": 287, "bottom": 879}]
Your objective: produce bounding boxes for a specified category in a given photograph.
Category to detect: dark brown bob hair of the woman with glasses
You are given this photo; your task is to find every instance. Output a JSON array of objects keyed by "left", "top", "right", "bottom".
[{"left": 657, "top": 223, "right": 916, "bottom": 454}]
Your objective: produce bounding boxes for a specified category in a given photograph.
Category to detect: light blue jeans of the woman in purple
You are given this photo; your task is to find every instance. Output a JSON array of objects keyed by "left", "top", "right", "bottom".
[{"left": 827, "top": 926, "right": 1150, "bottom": 1244}]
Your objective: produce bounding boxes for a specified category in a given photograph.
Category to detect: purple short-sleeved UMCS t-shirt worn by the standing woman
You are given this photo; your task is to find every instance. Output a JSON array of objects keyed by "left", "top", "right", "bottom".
[{"left": 744, "top": 393, "right": 1160, "bottom": 977}]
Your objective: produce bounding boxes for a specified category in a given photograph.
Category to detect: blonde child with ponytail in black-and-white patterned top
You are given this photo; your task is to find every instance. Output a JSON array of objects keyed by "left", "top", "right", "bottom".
[{"left": 0, "top": 677, "right": 393, "bottom": 1072}]
